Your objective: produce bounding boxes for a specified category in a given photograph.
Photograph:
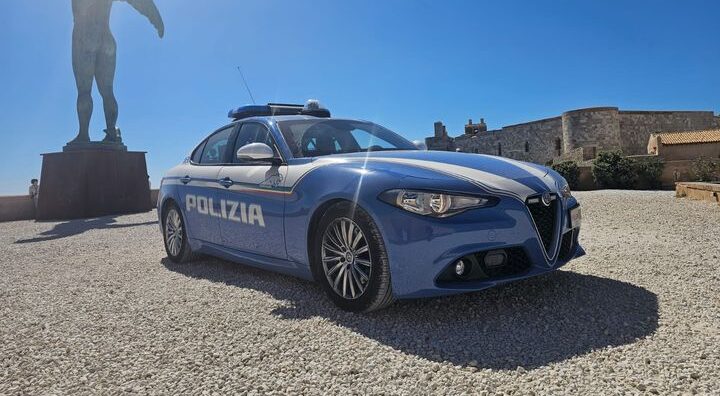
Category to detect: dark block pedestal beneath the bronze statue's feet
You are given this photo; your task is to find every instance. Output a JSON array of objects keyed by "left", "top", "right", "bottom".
[{"left": 37, "top": 149, "right": 153, "bottom": 220}]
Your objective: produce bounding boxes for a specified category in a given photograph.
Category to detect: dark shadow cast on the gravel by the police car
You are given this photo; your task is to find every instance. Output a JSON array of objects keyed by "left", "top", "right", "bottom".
[{"left": 162, "top": 258, "right": 658, "bottom": 369}]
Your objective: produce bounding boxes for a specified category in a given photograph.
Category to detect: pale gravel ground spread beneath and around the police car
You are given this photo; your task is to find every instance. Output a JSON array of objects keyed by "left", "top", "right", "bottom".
[{"left": 0, "top": 191, "right": 720, "bottom": 394}]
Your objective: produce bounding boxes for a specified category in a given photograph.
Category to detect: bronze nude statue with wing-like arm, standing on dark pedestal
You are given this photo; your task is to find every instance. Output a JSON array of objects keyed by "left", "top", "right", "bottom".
[{"left": 68, "top": 0, "right": 165, "bottom": 145}]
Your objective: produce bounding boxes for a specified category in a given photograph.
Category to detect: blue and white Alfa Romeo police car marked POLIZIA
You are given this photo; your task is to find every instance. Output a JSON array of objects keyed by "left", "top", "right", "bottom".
[{"left": 158, "top": 101, "right": 585, "bottom": 312}]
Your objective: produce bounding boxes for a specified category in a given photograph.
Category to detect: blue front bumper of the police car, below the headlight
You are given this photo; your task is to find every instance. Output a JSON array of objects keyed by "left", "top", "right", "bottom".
[{"left": 375, "top": 193, "right": 585, "bottom": 298}]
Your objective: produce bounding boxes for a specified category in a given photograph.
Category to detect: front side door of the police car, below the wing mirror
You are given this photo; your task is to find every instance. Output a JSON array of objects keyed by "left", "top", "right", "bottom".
[{"left": 219, "top": 122, "right": 287, "bottom": 259}]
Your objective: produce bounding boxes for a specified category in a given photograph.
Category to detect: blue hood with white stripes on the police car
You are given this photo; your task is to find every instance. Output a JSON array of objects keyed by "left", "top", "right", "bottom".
[{"left": 321, "top": 150, "right": 559, "bottom": 200}]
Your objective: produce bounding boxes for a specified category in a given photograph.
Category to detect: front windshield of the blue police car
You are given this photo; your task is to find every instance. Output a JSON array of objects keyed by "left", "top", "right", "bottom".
[{"left": 278, "top": 119, "right": 417, "bottom": 158}]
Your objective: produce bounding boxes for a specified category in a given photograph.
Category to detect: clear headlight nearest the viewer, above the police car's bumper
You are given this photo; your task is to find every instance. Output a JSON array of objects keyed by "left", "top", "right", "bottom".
[{"left": 379, "top": 190, "right": 495, "bottom": 217}]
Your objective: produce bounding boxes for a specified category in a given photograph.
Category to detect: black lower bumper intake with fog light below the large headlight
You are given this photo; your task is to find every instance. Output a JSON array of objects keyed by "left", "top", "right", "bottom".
[{"left": 438, "top": 247, "right": 532, "bottom": 282}]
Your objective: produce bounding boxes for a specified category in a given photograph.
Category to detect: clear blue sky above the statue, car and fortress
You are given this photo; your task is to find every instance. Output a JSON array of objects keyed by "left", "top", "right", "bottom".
[{"left": 0, "top": 0, "right": 720, "bottom": 195}]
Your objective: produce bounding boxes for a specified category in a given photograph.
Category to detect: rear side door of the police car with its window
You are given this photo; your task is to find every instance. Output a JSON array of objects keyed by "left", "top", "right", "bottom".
[{"left": 178, "top": 125, "right": 235, "bottom": 243}]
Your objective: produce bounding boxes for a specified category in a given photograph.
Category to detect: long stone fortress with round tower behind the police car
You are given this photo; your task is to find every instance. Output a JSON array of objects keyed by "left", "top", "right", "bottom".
[{"left": 425, "top": 107, "right": 720, "bottom": 164}]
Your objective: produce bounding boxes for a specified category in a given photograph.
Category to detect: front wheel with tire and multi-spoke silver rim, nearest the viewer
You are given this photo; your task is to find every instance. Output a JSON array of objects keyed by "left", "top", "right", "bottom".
[{"left": 312, "top": 202, "right": 395, "bottom": 312}]
